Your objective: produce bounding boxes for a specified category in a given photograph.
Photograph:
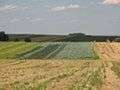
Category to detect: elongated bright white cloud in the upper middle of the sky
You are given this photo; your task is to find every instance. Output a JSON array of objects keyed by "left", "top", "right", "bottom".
[{"left": 51, "top": 4, "right": 80, "bottom": 11}]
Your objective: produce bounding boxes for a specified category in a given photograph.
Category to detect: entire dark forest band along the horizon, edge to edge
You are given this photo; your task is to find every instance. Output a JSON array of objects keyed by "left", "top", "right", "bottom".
[{"left": 0, "top": 31, "right": 120, "bottom": 42}]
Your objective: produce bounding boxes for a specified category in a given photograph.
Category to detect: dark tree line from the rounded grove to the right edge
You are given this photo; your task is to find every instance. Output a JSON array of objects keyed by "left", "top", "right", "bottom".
[{"left": 64, "top": 33, "right": 120, "bottom": 42}]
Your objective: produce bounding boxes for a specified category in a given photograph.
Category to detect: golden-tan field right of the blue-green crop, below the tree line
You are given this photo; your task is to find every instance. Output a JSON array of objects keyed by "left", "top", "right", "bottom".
[{"left": 95, "top": 42, "right": 120, "bottom": 61}]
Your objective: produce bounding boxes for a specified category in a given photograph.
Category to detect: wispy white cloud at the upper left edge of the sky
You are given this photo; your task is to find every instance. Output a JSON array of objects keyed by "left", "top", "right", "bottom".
[{"left": 0, "top": 4, "right": 29, "bottom": 11}]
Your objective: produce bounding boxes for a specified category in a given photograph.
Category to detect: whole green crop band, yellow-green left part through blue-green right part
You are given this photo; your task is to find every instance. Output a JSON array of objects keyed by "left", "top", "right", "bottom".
[{"left": 0, "top": 42, "right": 98, "bottom": 59}]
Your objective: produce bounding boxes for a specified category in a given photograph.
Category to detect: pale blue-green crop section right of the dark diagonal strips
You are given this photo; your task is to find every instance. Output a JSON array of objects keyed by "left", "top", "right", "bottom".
[{"left": 55, "top": 42, "right": 98, "bottom": 59}]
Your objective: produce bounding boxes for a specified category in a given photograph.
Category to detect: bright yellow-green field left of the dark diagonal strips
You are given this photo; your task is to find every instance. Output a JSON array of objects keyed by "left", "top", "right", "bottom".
[{"left": 0, "top": 42, "right": 40, "bottom": 59}]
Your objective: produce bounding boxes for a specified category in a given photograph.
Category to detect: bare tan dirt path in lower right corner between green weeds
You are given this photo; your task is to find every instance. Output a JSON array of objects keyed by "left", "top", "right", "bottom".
[{"left": 102, "top": 62, "right": 120, "bottom": 90}]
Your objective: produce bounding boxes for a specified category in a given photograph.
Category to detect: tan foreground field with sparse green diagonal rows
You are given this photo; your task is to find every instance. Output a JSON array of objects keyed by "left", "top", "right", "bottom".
[{"left": 0, "top": 60, "right": 120, "bottom": 90}]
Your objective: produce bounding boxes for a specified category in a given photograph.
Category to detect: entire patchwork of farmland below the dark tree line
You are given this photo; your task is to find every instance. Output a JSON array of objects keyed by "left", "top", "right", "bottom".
[{"left": 0, "top": 42, "right": 120, "bottom": 90}]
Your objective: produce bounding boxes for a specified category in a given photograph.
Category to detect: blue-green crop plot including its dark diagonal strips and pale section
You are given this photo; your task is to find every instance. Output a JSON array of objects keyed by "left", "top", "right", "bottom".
[{"left": 20, "top": 42, "right": 98, "bottom": 59}]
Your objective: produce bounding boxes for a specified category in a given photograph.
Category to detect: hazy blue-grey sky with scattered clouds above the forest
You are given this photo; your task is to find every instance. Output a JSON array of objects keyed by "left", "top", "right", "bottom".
[{"left": 0, "top": 0, "right": 120, "bottom": 35}]
